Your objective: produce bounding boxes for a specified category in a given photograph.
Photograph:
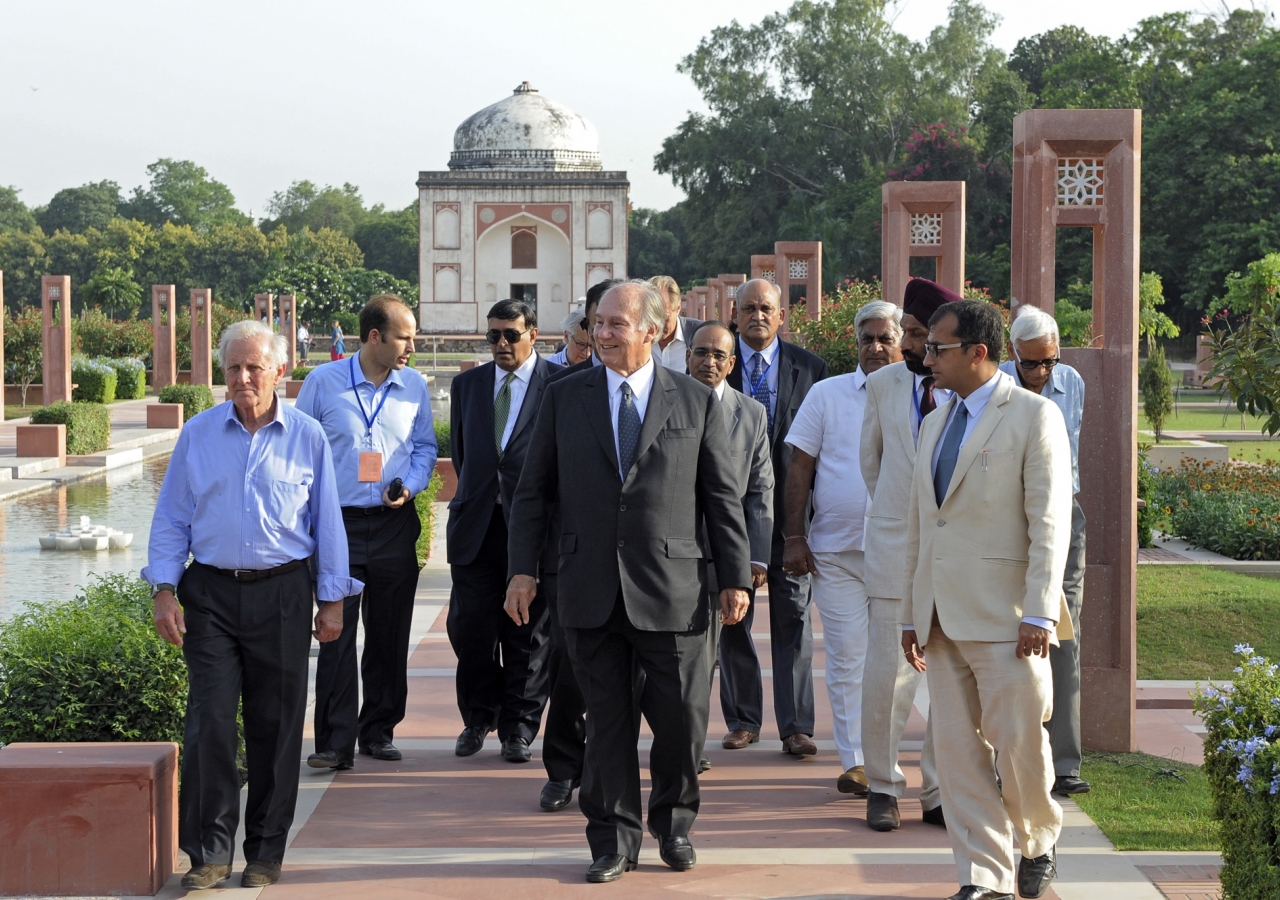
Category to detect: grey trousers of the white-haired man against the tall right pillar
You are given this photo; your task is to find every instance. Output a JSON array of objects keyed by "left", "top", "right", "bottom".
[{"left": 1044, "top": 499, "right": 1084, "bottom": 776}]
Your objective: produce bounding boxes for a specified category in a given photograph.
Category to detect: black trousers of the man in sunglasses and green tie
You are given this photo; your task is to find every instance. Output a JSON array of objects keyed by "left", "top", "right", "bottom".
[{"left": 447, "top": 506, "right": 550, "bottom": 741}]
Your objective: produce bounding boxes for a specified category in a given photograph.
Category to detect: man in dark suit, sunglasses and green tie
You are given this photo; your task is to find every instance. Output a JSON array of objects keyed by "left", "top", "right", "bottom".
[{"left": 447, "top": 300, "right": 559, "bottom": 763}]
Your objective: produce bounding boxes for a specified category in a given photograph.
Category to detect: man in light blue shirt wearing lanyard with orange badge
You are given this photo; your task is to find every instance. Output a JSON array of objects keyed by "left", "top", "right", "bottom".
[{"left": 297, "top": 294, "right": 436, "bottom": 769}]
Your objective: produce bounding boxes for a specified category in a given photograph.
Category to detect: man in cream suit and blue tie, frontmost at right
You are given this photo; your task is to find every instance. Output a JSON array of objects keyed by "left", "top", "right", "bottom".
[{"left": 901, "top": 301, "right": 1071, "bottom": 900}]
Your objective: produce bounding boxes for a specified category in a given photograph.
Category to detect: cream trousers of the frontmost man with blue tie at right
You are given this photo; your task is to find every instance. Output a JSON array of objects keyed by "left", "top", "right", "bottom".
[{"left": 924, "top": 621, "right": 1062, "bottom": 892}]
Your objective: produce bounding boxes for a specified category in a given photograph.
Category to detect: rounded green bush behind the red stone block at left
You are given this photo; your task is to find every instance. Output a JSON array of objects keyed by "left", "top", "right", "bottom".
[{"left": 0, "top": 575, "right": 187, "bottom": 744}]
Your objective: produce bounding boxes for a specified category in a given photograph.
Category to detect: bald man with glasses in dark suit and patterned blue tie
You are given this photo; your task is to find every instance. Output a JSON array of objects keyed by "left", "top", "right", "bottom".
[{"left": 721, "top": 278, "right": 827, "bottom": 757}]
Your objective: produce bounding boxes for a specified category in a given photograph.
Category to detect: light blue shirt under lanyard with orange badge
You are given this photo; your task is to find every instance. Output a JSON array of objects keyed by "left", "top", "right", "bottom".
[{"left": 296, "top": 351, "right": 438, "bottom": 508}]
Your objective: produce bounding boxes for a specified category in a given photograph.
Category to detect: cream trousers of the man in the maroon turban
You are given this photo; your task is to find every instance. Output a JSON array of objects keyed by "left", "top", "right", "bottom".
[{"left": 863, "top": 597, "right": 942, "bottom": 809}]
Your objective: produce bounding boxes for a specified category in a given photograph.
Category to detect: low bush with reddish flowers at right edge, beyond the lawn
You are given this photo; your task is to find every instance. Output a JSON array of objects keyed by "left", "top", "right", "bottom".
[{"left": 1156, "top": 460, "right": 1280, "bottom": 559}]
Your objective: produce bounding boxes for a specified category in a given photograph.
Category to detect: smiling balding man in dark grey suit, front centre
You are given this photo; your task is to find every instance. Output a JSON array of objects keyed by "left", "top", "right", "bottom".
[{"left": 507, "top": 282, "right": 751, "bottom": 882}]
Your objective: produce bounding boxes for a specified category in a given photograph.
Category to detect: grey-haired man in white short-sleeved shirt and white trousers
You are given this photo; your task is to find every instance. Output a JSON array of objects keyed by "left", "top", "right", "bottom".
[{"left": 782, "top": 300, "right": 902, "bottom": 796}]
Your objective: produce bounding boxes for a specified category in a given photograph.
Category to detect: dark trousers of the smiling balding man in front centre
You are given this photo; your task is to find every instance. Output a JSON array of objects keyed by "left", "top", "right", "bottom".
[{"left": 564, "top": 595, "right": 710, "bottom": 860}]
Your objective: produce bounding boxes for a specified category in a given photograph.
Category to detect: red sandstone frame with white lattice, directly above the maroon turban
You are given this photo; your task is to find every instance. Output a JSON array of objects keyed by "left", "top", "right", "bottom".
[{"left": 881, "top": 182, "right": 965, "bottom": 306}]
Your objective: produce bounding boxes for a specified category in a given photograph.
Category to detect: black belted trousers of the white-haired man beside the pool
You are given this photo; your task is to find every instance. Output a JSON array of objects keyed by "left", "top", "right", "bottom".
[{"left": 178, "top": 562, "right": 312, "bottom": 867}]
